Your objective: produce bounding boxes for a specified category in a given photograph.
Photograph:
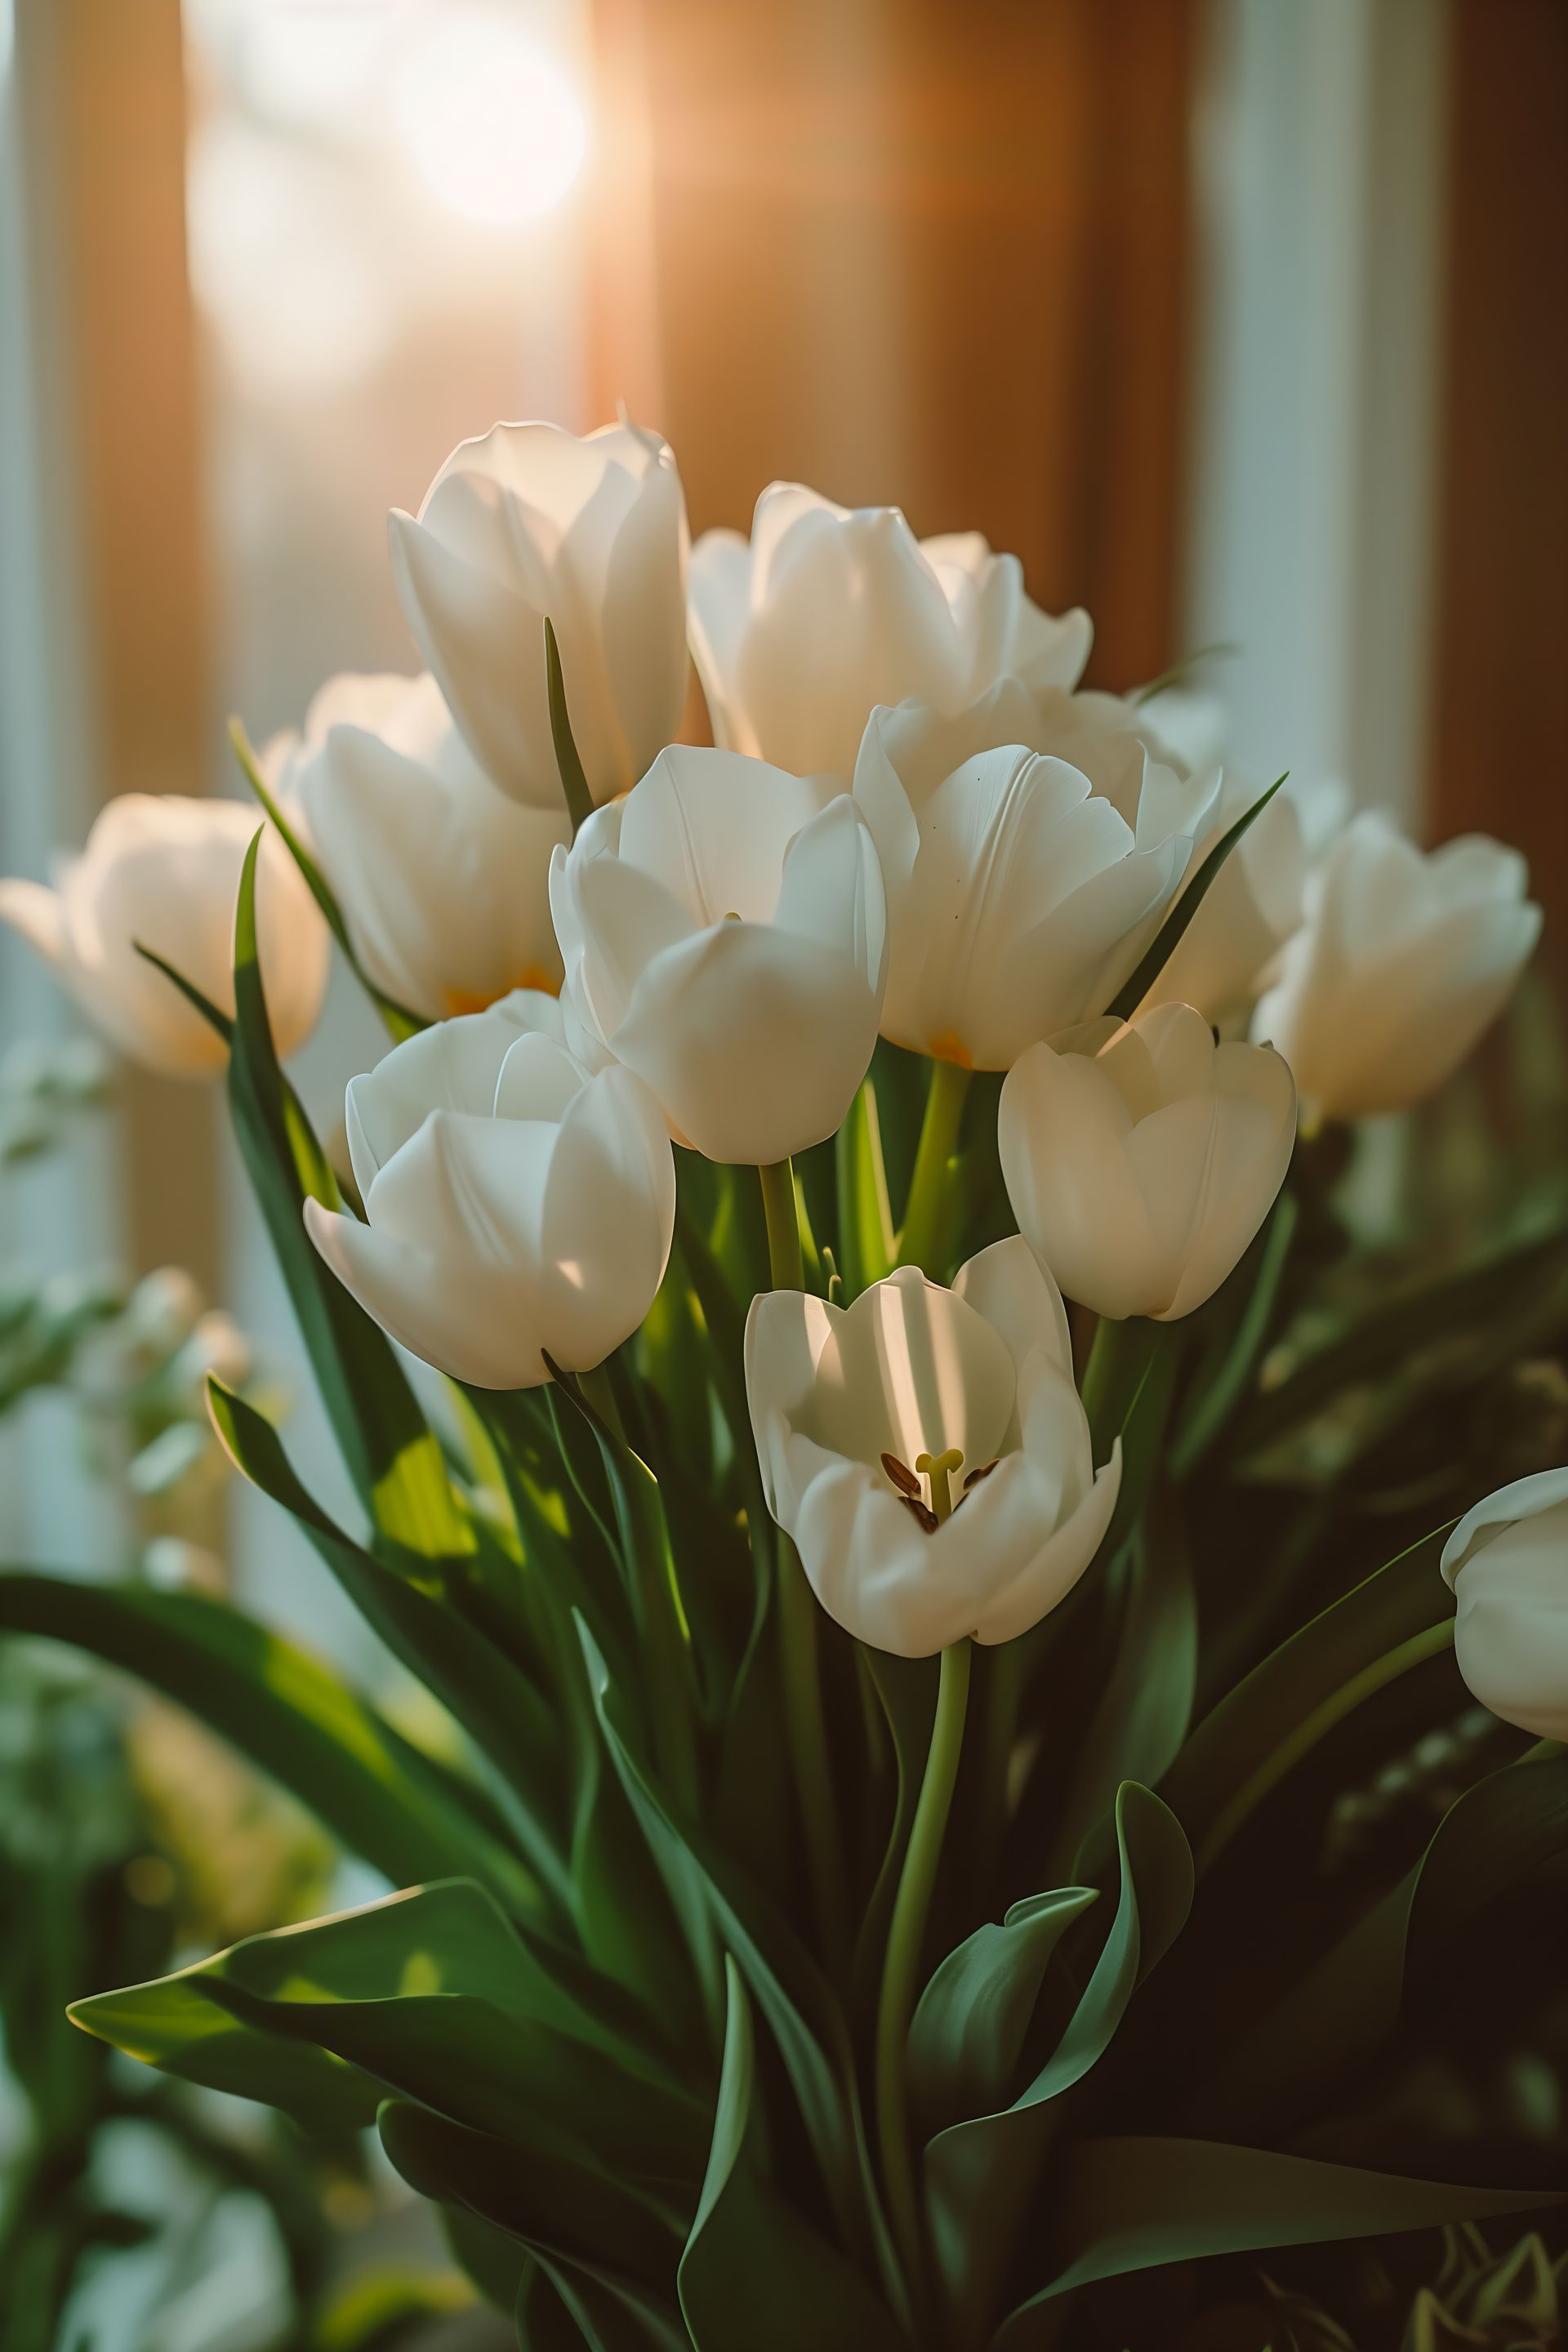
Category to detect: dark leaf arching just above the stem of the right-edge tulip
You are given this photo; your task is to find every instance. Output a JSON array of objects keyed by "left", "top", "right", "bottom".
[{"left": 1161, "top": 1526, "right": 1453, "bottom": 1858}]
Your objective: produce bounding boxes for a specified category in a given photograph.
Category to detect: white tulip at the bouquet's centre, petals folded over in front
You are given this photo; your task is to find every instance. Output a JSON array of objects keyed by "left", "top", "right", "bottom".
[{"left": 550, "top": 746, "right": 886, "bottom": 1165}]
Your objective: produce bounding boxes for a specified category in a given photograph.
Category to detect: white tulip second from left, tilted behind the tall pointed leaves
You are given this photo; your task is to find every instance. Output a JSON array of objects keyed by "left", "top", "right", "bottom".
[{"left": 263, "top": 673, "right": 569, "bottom": 1021}]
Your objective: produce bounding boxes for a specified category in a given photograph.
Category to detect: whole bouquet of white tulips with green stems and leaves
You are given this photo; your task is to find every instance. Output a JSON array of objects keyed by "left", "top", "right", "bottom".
[{"left": 0, "top": 423, "right": 1568, "bottom": 2352}]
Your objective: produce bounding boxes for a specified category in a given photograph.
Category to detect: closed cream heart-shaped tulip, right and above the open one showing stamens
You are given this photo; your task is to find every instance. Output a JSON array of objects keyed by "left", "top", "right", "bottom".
[{"left": 997, "top": 1004, "right": 1295, "bottom": 1322}]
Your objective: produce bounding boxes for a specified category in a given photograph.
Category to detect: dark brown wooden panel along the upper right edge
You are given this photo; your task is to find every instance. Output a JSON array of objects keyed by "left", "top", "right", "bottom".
[{"left": 1432, "top": 0, "right": 1568, "bottom": 983}]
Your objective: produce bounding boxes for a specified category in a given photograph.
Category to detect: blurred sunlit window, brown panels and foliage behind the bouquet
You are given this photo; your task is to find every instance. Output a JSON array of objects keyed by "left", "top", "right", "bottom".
[{"left": 0, "top": 0, "right": 1568, "bottom": 2352}]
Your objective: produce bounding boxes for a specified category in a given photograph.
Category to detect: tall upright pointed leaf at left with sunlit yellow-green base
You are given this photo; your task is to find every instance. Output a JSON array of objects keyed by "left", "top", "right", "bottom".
[{"left": 228, "top": 833, "right": 474, "bottom": 1559}]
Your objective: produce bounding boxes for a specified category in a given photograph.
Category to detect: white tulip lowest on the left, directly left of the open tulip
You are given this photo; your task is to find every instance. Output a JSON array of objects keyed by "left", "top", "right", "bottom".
[{"left": 305, "top": 990, "right": 675, "bottom": 1388}]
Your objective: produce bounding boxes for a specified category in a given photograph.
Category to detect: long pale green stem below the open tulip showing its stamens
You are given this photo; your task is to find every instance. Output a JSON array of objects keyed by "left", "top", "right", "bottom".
[{"left": 877, "top": 1639, "right": 971, "bottom": 2307}]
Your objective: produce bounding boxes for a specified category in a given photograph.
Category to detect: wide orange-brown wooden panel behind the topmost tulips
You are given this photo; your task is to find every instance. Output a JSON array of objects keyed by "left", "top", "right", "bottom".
[{"left": 597, "top": 0, "right": 1192, "bottom": 682}]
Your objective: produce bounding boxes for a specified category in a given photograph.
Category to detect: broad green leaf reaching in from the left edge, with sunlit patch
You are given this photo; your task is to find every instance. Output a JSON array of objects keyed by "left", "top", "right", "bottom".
[{"left": 0, "top": 1571, "right": 533, "bottom": 1917}]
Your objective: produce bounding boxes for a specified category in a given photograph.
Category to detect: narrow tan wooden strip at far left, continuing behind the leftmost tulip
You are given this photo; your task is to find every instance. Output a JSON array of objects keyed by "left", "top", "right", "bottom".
[{"left": 16, "top": 0, "right": 219, "bottom": 1289}]
